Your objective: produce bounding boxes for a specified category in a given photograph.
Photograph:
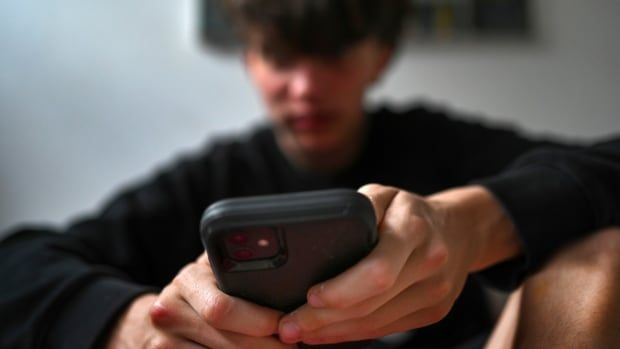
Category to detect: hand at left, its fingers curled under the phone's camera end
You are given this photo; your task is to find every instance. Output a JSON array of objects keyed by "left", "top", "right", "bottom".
[{"left": 107, "top": 254, "right": 294, "bottom": 349}]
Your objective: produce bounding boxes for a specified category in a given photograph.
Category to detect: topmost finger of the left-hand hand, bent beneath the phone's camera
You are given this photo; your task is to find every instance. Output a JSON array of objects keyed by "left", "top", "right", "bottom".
[{"left": 175, "top": 263, "right": 282, "bottom": 337}]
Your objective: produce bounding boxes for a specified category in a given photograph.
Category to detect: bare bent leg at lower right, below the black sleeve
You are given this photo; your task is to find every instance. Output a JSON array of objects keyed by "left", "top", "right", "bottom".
[{"left": 487, "top": 228, "right": 620, "bottom": 348}]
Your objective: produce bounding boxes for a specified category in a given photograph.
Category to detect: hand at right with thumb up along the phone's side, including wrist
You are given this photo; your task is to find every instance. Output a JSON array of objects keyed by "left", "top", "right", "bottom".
[{"left": 279, "top": 185, "right": 520, "bottom": 344}]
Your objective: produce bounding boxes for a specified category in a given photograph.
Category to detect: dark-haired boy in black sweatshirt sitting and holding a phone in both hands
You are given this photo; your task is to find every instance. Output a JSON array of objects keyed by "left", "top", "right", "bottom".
[{"left": 0, "top": 0, "right": 620, "bottom": 348}]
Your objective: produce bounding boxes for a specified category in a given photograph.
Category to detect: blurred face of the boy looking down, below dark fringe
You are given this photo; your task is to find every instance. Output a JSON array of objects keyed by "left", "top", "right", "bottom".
[{"left": 246, "top": 39, "right": 390, "bottom": 165}]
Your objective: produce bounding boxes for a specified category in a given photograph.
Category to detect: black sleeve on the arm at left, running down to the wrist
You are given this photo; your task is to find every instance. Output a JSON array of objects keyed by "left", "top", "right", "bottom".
[{"left": 0, "top": 141, "right": 237, "bottom": 349}]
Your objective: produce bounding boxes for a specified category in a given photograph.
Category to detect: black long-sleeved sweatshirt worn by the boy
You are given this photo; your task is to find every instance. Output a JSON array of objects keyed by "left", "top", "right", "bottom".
[{"left": 0, "top": 107, "right": 620, "bottom": 349}]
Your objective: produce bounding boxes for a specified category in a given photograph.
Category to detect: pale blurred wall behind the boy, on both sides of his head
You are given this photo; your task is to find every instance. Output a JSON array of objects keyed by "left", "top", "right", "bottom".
[{"left": 0, "top": 0, "right": 620, "bottom": 235}]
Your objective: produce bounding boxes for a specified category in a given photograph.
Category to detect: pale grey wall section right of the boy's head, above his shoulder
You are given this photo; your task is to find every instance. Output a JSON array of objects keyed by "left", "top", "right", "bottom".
[{"left": 372, "top": 0, "right": 620, "bottom": 137}]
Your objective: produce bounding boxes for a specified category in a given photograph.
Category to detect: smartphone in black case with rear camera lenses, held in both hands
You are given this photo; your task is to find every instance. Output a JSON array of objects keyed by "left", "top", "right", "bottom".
[{"left": 200, "top": 189, "right": 377, "bottom": 312}]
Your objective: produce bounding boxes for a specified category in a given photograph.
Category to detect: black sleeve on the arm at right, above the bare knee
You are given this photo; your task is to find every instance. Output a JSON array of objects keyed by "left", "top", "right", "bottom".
[{"left": 480, "top": 138, "right": 620, "bottom": 290}]
